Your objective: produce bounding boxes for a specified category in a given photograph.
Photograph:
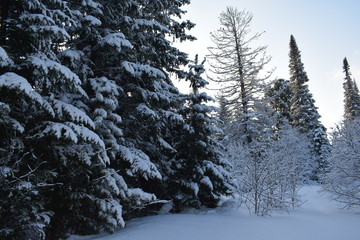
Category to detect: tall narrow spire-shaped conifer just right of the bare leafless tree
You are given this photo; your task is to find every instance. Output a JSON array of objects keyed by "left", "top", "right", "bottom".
[{"left": 289, "top": 35, "right": 330, "bottom": 180}]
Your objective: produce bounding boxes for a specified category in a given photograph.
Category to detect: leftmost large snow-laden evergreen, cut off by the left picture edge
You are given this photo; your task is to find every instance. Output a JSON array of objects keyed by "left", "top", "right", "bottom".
[{"left": 0, "top": 0, "right": 93, "bottom": 239}]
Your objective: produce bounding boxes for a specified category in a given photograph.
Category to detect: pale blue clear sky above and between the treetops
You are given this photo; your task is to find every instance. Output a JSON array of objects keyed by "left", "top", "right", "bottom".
[{"left": 176, "top": 0, "right": 360, "bottom": 130}]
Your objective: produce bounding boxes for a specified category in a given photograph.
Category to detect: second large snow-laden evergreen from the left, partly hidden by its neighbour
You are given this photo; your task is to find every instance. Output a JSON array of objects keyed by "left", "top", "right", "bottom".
[{"left": 60, "top": 1, "right": 161, "bottom": 231}]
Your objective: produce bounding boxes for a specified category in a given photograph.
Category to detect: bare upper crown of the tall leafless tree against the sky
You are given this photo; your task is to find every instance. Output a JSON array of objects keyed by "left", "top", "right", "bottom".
[{"left": 208, "top": 7, "right": 271, "bottom": 125}]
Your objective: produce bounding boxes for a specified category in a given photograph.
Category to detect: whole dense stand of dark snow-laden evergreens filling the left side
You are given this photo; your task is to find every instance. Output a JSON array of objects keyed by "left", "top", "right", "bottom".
[{"left": 0, "top": 0, "right": 235, "bottom": 239}]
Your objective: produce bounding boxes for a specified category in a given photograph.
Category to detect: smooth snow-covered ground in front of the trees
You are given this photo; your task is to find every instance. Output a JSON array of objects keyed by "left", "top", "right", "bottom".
[{"left": 71, "top": 186, "right": 360, "bottom": 240}]
